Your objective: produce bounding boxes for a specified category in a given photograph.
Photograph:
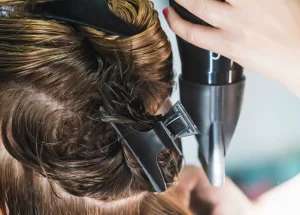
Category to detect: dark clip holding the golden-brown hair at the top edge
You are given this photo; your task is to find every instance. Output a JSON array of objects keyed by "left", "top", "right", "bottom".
[{"left": 41, "top": 0, "right": 137, "bottom": 37}]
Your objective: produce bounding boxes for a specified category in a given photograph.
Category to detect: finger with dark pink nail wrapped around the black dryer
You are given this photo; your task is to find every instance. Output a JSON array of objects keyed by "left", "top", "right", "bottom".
[{"left": 166, "top": 7, "right": 227, "bottom": 54}]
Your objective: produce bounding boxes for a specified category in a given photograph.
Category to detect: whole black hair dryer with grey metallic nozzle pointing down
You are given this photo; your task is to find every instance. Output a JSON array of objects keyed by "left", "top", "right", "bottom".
[{"left": 170, "top": 0, "right": 245, "bottom": 187}]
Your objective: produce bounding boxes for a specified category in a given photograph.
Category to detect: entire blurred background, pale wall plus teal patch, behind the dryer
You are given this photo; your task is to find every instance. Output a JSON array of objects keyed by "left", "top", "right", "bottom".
[{"left": 153, "top": 0, "right": 300, "bottom": 198}]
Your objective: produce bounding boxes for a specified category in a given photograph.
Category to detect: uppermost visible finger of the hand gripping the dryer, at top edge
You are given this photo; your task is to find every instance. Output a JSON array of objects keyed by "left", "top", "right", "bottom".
[{"left": 176, "top": 0, "right": 231, "bottom": 28}]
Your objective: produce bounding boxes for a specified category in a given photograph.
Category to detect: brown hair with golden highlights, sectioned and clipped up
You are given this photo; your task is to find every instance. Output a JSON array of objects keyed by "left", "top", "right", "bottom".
[{"left": 0, "top": 0, "right": 192, "bottom": 215}]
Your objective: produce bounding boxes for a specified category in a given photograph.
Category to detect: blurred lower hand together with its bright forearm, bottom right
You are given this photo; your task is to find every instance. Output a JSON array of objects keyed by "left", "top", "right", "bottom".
[{"left": 171, "top": 166, "right": 300, "bottom": 215}]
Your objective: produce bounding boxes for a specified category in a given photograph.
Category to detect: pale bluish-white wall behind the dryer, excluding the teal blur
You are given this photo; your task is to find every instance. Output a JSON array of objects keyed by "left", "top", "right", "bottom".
[{"left": 154, "top": 0, "right": 300, "bottom": 168}]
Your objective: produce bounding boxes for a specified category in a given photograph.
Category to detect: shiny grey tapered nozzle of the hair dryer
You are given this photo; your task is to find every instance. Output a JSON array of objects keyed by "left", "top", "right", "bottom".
[{"left": 180, "top": 76, "right": 245, "bottom": 186}]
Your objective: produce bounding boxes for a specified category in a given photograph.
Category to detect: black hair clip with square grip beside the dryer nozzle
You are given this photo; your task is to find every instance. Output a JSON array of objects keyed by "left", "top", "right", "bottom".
[{"left": 100, "top": 102, "right": 199, "bottom": 192}]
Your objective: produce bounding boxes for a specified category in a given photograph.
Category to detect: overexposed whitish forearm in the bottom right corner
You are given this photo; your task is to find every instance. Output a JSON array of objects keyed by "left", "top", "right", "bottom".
[{"left": 253, "top": 175, "right": 300, "bottom": 215}]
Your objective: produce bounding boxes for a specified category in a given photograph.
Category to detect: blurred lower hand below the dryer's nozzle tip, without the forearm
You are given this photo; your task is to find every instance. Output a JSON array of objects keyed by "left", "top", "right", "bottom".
[{"left": 172, "top": 166, "right": 256, "bottom": 215}]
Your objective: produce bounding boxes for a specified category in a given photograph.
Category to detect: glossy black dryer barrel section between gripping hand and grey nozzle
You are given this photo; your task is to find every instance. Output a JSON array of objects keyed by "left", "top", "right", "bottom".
[{"left": 177, "top": 37, "right": 244, "bottom": 85}]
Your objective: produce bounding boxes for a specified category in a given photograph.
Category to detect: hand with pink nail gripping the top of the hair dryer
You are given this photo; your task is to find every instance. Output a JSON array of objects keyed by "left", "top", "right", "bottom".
[{"left": 164, "top": 0, "right": 300, "bottom": 96}]
